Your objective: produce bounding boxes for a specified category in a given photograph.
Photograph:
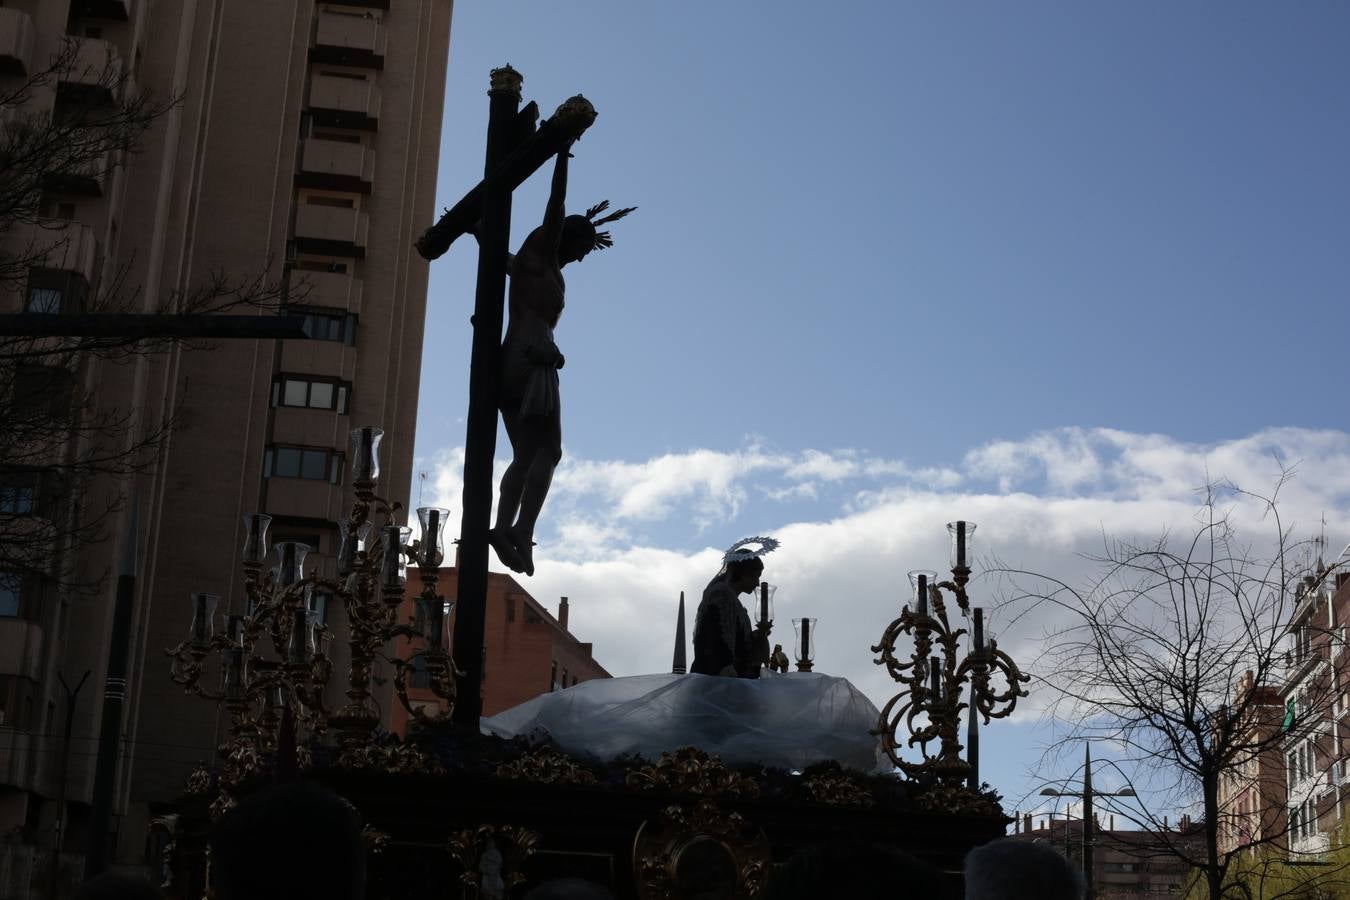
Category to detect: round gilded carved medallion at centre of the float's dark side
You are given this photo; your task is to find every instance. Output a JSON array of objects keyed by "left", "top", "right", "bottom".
[{"left": 633, "top": 800, "right": 771, "bottom": 900}]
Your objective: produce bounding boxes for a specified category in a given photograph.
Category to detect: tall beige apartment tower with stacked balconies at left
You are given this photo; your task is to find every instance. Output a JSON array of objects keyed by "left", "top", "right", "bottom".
[{"left": 0, "top": 0, "right": 451, "bottom": 861}]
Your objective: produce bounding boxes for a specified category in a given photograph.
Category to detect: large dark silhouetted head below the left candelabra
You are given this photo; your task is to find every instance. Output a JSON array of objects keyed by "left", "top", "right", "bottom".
[{"left": 211, "top": 781, "right": 366, "bottom": 900}]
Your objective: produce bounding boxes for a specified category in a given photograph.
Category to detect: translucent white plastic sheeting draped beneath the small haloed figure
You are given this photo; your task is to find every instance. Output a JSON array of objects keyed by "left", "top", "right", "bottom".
[{"left": 482, "top": 672, "right": 890, "bottom": 772}]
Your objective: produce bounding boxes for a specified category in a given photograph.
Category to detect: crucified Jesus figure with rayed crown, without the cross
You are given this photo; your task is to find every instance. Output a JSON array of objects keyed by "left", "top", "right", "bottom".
[{"left": 489, "top": 142, "right": 635, "bottom": 575}]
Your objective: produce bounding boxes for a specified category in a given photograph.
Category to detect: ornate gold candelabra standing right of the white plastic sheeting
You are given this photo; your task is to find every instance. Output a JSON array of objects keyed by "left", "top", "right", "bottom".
[{"left": 872, "top": 522, "right": 1030, "bottom": 783}]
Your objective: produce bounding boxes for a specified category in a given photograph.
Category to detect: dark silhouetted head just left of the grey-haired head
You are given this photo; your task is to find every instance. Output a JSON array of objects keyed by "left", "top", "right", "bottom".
[{"left": 760, "top": 843, "right": 945, "bottom": 900}]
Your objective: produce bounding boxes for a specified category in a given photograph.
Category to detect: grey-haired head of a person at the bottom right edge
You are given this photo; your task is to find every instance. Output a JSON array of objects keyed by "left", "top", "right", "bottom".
[{"left": 965, "top": 838, "right": 1084, "bottom": 900}]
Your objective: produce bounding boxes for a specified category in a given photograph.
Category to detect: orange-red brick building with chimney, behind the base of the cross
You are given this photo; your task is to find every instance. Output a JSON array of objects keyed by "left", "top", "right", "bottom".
[{"left": 392, "top": 567, "right": 610, "bottom": 734}]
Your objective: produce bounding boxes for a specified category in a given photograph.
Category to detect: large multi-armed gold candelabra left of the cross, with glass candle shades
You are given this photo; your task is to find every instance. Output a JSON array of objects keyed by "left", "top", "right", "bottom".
[{"left": 166, "top": 426, "right": 456, "bottom": 787}]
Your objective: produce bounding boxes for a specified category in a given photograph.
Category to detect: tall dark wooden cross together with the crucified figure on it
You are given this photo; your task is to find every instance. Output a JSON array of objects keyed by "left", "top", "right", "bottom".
[{"left": 417, "top": 66, "right": 632, "bottom": 731}]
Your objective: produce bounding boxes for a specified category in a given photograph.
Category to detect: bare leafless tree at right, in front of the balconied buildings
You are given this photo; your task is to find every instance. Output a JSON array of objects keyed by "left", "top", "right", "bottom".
[{"left": 994, "top": 472, "right": 1350, "bottom": 900}]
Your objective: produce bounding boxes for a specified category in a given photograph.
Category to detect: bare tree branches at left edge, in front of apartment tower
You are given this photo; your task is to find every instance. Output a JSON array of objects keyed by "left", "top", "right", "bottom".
[{"left": 0, "top": 38, "right": 294, "bottom": 596}]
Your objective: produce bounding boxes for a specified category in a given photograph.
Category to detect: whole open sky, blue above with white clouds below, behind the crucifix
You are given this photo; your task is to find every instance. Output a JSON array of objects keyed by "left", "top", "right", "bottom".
[{"left": 413, "top": 0, "right": 1350, "bottom": 825}]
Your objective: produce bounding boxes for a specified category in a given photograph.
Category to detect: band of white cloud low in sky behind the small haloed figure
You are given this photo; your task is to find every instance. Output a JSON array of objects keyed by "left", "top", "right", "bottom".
[{"left": 413, "top": 428, "right": 1350, "bottom": 793}]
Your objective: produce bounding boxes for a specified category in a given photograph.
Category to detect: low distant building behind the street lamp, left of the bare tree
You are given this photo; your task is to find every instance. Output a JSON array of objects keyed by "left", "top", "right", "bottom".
[{"left": 1013, "top": 814, "right": 1204, "bottom": 900}]
